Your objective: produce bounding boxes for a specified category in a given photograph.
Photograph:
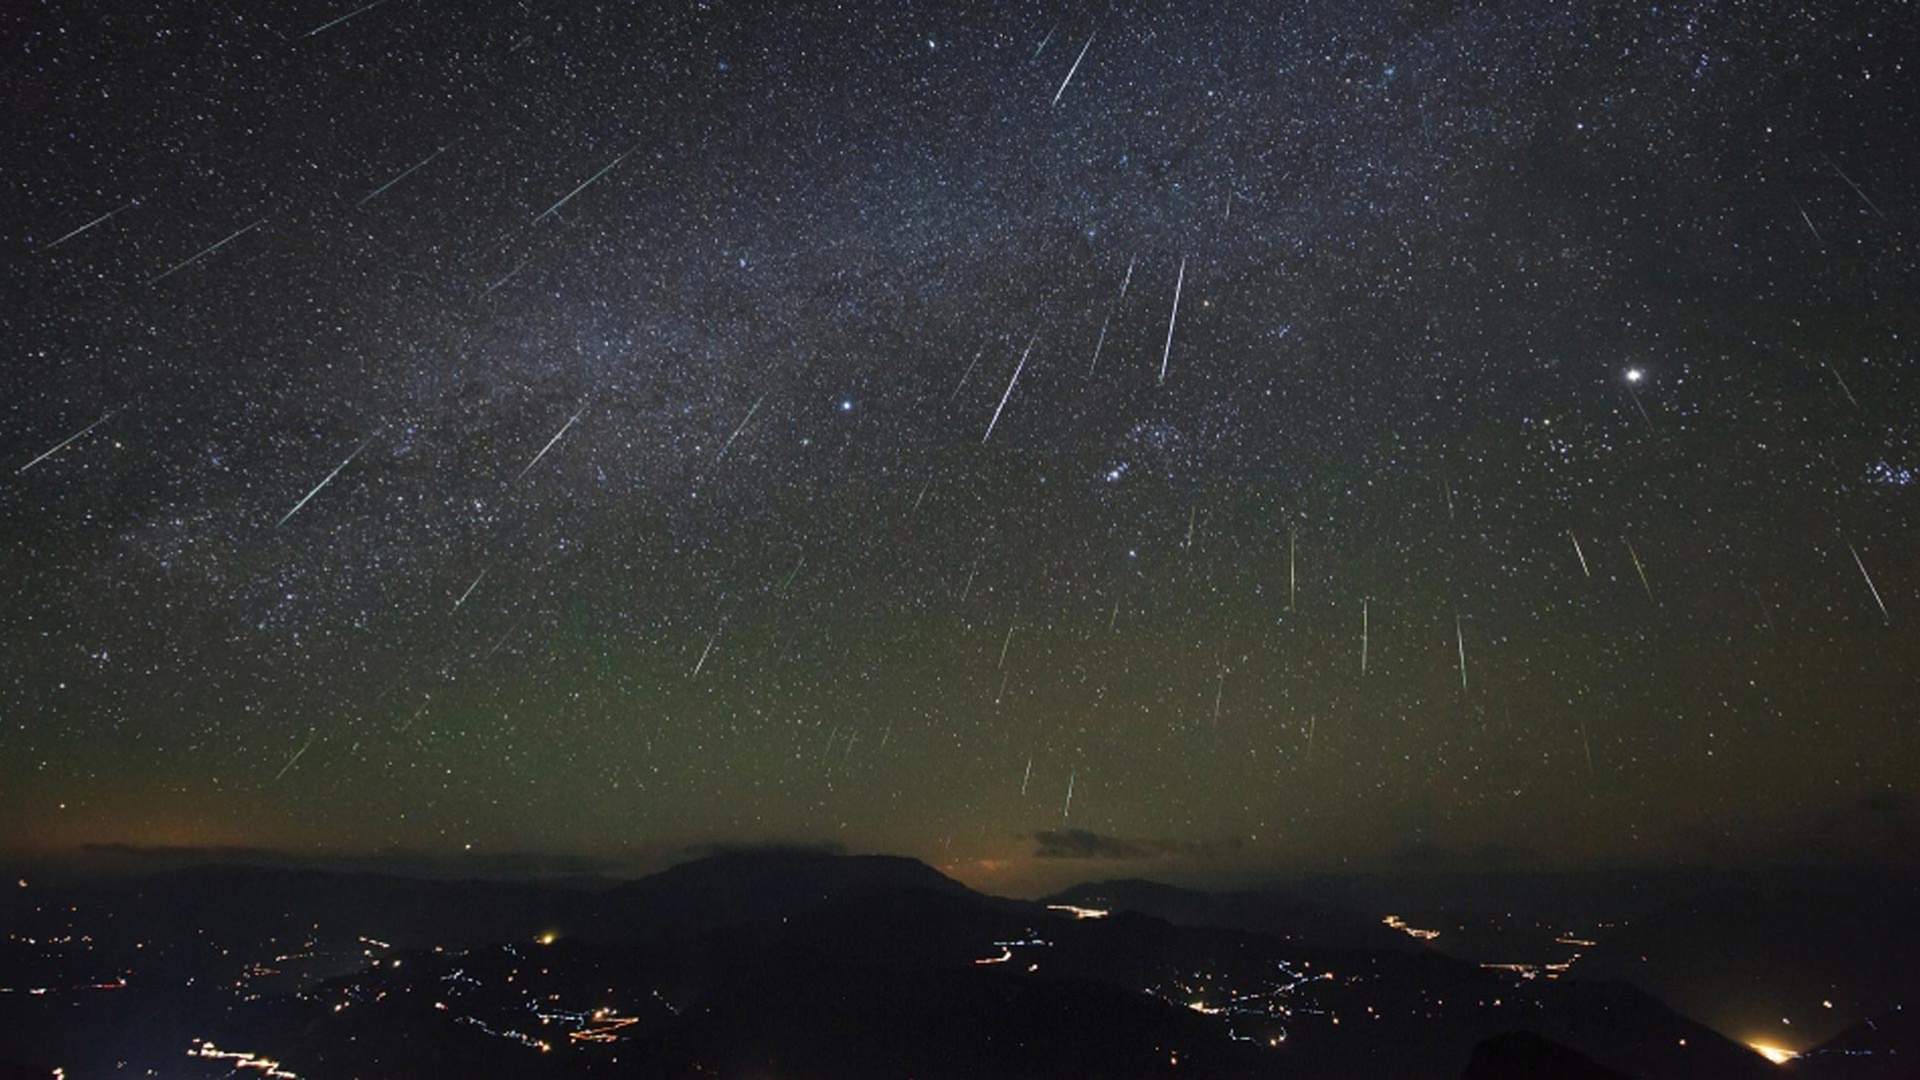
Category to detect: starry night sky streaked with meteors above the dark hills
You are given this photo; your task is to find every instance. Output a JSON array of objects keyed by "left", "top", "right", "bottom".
[{"left": 0, "top": 0, "right": 1920, "bottom": 890}]
